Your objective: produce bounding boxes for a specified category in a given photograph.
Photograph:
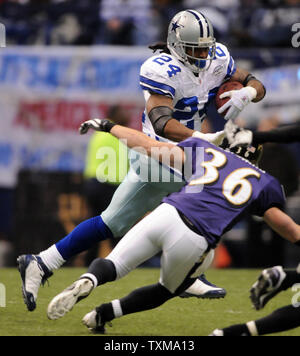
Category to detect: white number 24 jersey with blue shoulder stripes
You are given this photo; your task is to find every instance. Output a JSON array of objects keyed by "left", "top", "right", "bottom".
[{"left": 140, "top": 43, "right": 236, "bottom": 141}]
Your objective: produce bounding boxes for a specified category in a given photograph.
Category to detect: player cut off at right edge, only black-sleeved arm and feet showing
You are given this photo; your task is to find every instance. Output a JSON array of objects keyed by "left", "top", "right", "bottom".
[{"left": 211, "top": 121, "right": 300, "bottom": 336}]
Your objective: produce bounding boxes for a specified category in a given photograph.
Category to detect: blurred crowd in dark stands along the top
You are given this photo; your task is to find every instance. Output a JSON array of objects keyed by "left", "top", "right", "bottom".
[{"left": 0, "top": 0, "right": 300, "bottom": 47}]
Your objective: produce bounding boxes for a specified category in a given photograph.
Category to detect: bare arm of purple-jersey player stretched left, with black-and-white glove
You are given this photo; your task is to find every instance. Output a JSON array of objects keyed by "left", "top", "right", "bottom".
[{"left": 79, "top": 119, "right": 185, "bottom": 168}]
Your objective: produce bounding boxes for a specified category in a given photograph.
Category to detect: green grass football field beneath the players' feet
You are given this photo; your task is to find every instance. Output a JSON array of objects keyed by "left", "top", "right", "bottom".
[{"left": 0, "top": 268, "right": 300, "bottom": 336}]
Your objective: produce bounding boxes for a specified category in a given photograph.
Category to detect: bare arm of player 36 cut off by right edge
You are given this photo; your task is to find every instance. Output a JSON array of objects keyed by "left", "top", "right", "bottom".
[{"left": 264, "top": 207, "right": 300, "bottom": 245}]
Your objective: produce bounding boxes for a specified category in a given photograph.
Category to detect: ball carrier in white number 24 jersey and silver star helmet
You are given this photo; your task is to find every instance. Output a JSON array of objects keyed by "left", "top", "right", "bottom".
[{"left": 18, "top": 10, "right": 265, "bottom": 311}]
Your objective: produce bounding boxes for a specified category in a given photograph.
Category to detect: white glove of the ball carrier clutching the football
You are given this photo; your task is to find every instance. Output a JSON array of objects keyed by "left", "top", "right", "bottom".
[{"left": 218, "top": 86, "right": 257, "bottom": 120}]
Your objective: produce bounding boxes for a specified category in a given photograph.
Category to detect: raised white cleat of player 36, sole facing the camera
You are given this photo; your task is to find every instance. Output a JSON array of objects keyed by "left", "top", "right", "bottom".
[{"left": 47, "top": 278, "right": 94, "bottom": 320}]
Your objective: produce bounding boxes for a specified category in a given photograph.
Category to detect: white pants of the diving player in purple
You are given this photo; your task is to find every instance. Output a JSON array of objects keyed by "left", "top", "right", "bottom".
[{"left": 106, "top": 203, "right": 213, "bottom": 293}]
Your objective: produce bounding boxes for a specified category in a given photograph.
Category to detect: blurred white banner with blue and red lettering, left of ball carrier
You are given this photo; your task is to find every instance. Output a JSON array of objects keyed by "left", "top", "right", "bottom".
[{"left": 0, "top": 47, "right": 151, "bottom": 187}]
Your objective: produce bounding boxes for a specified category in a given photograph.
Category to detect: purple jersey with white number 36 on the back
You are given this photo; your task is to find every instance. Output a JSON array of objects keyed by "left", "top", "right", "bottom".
[{"left": 163, "top": 138, "right": 285, "bottom": 246}]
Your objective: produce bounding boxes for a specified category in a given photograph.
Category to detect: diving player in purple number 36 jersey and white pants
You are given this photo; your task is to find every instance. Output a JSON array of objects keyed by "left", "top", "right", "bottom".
[{"left": 48, "top": 119, "right": 300, "bottom": 333}]
